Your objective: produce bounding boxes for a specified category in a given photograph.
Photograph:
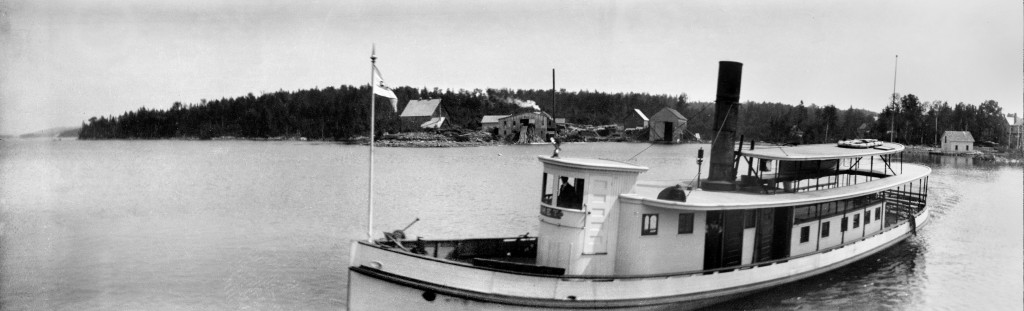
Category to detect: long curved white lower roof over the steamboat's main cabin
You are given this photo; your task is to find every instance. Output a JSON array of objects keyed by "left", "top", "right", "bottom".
[{"left": 620, "top": 164, "right": 932, "bottom": 211}]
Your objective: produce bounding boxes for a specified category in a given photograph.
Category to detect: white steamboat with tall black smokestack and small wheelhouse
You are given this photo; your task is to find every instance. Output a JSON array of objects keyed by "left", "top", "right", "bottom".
[{"left": 348, "top": 61, "right": 931, "bottom": 310}]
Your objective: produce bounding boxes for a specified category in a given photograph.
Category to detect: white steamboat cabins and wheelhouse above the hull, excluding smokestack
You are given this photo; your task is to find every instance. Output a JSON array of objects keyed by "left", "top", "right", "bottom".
[{"left": 536, "top": 143, "right": 928, "bottom": 275}]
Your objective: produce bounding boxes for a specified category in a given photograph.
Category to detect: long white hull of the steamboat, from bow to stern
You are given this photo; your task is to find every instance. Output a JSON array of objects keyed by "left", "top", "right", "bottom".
[{"left": 348, "top": 208, "right": 929, "bottom": 310}]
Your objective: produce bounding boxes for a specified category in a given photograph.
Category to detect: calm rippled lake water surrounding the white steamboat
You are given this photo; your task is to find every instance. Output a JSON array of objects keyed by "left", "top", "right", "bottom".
[{"left": 0, "top": 141, "right": 1024, "bottom": 310}]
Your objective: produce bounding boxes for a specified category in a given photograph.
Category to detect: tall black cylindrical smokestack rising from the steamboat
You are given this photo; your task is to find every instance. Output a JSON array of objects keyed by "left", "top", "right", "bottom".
[{"left": 702, "top": 61, "right": 743, "bottom": 191}]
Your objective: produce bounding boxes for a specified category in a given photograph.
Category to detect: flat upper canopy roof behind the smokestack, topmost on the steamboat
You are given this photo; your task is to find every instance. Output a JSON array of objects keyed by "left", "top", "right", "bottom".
[{"left": 742, "top": 142, "right": 904, "bottom": 161}]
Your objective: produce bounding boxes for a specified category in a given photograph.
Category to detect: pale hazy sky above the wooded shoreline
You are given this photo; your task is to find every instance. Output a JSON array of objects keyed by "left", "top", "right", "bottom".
[{"left": 0, "top": 0, "right": 1024, "bottom": 135}]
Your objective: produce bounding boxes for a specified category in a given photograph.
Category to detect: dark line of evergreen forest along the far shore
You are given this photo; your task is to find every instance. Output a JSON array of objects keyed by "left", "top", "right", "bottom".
[{"left": 79, "top": 85, "right": 1007, "bottom": 144}]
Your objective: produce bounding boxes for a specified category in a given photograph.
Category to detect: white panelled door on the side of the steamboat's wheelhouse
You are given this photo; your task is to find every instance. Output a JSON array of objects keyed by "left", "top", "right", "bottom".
[{"left": 583, "top": 177, "right": 612, "bottom": 255}]
